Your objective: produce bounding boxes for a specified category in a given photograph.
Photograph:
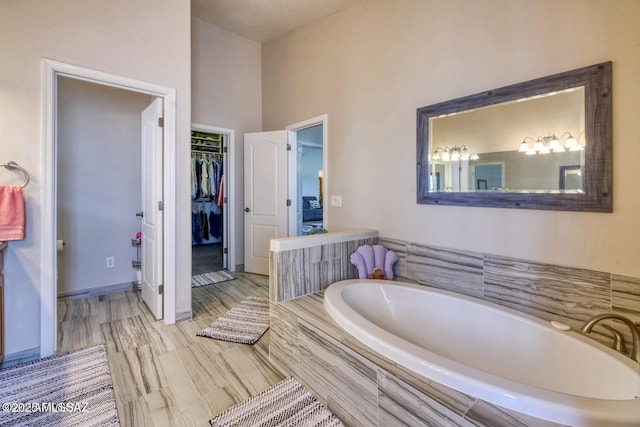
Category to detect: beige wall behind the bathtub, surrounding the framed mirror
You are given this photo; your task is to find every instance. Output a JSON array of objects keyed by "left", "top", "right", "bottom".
[{"left": 262, "top": 0, "right": 640, "bottom": 276}]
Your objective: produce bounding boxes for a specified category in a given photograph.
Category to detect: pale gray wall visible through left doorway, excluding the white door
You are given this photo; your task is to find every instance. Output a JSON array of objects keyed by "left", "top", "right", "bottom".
[{"left": 56, "top": 77, "right": 153, "bottom": 298}]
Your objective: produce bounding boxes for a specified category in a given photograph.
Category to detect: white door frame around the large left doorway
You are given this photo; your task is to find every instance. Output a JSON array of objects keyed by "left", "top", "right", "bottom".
[{"left": 40, "top": 58, "right": 177, "bottom": 357}]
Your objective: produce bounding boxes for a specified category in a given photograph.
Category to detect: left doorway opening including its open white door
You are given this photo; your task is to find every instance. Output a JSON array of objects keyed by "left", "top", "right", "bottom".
[{"left": 56, "top": 76, "right": 164, "bottom": 319}]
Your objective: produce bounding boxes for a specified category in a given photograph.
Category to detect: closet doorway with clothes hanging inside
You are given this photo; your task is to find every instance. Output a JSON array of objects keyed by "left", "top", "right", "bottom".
[{"left": 191, "top": 125, "right": 234, "bottom": 276}]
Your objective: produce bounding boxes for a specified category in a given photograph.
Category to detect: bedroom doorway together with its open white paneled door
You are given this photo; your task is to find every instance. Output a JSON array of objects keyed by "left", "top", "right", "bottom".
[{"left": 244, "top": 114, "right": 329, "bottom": 274}]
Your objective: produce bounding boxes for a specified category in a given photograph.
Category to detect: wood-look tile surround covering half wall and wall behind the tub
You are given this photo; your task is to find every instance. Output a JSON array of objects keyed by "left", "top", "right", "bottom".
[{"left": 269, "top": 230, "right": 640, "bottom": 334}]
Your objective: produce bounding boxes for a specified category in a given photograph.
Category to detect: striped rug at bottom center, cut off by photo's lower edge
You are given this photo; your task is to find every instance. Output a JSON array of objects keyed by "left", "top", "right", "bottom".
[{"left": 209, "top": 378, "right": 343, "bottom": 427}]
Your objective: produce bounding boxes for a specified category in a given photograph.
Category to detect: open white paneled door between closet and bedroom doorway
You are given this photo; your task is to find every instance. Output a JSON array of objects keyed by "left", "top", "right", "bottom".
[{"left": 244, "top": 131, "right": 287, "bottom": 275}]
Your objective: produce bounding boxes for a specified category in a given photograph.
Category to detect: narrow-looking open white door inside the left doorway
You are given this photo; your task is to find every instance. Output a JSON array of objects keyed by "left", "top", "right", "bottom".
[{"left": 141, "top": 98, "right": 163, "bottom": 319}]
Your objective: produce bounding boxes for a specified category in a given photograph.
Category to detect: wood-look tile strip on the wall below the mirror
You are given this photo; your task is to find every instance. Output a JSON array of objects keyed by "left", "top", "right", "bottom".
[{"left": 379, "top": 237, "right": 640, "bottom": 338}]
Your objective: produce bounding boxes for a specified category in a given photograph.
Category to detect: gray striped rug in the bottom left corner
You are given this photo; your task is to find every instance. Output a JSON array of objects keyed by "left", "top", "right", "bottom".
[{"left": 0, "top": 344, "right": 120, "bottom": 427}]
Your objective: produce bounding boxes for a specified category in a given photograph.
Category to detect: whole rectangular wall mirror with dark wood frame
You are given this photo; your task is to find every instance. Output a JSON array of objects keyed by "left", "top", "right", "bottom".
[{"left": 417, "top": 62, "right": 612, "bottom": 212}]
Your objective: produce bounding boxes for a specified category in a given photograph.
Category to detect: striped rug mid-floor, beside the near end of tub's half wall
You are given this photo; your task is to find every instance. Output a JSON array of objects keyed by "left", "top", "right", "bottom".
[{"left": 196, "top": 297, "right": 269, "bottom": 344}]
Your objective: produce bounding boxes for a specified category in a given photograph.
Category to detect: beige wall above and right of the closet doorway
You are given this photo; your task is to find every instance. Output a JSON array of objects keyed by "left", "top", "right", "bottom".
[{"left": 191, "top": 19, "right": 262, "bottom": 265}]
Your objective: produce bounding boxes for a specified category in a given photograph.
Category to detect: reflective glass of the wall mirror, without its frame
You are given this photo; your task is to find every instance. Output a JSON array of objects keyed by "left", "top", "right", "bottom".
[{"left": 428, "top": 86, "right": 586, "bottom": 193}]
